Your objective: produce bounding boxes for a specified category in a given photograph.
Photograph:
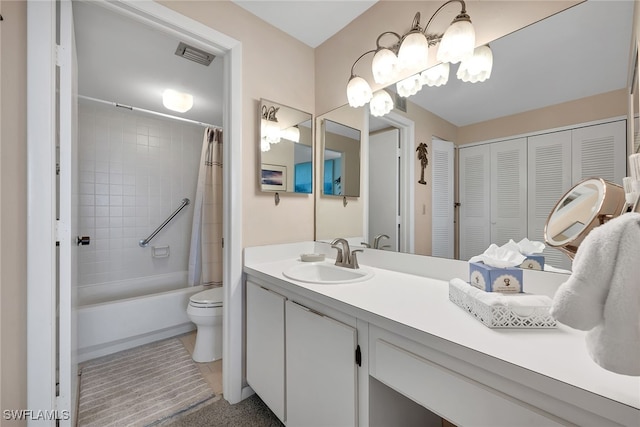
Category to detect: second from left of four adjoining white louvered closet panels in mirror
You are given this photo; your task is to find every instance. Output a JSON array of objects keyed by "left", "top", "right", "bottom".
[{"left": 491, "top": 138, "right": 528, "bottom": 246}]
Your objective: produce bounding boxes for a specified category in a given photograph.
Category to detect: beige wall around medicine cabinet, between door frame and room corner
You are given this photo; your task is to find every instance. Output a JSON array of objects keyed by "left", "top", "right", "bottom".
[{"left": 161, "top": 0, "right": 315, "bottom": 247}]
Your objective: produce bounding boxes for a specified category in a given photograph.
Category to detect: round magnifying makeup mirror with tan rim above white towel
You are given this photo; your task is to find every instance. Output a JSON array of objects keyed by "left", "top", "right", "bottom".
[{"left": 544, "top": 178, "right": 626, "bottom": 259}]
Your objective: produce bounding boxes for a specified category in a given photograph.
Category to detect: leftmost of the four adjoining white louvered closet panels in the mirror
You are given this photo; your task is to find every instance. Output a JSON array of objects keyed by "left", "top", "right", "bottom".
[{"left": 460, "top": 145, "right": 491, "bottom": 261}]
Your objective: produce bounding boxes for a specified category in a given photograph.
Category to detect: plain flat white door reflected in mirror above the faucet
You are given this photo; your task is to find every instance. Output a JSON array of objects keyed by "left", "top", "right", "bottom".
[{"left": 368, "top": 129, "right": 400, "bottom": 252}]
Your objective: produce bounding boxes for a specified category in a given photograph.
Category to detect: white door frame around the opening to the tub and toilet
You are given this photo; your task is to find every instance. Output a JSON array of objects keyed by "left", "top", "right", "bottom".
[{"left": 27, "top": 0, "right": 245, "bottom": 418}]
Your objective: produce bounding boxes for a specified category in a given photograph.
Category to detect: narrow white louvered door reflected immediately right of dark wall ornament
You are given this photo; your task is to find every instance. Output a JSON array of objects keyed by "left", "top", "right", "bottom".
[{"left": 431, "top": 138, "right": 454, "bottom": 258}]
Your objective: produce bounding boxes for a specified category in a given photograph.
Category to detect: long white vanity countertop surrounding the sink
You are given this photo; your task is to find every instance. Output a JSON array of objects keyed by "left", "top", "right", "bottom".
[{"left": 245, "top": 245, "right": 640, "bottom": 409}]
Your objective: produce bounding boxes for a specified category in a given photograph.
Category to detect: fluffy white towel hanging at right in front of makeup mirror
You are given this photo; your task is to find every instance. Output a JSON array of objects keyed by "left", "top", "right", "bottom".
[{"left": 551, "top": 213, "right": 640, "bottom": 376}]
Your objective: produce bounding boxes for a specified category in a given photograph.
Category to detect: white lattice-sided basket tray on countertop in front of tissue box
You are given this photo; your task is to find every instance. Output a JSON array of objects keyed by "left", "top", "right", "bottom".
[{"left": 449, "top": 280, "right": 557, "bottom": 329}]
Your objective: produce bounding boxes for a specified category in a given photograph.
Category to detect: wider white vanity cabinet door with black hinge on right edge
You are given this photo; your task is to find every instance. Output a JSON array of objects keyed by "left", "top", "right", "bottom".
[{"left": 286, "top": 301, "right": 357, "bottom": 427}]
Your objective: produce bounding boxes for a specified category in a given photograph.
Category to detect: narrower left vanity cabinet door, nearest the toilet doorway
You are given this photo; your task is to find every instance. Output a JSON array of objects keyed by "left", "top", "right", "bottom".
[{"left": 247, "top": 282, "right": 285, "bottom": 422}]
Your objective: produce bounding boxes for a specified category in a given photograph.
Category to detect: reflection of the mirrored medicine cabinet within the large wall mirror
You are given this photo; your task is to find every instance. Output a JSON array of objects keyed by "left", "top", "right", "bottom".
[{"left": 321, "top": 119, "right": 360, "bottom": 197}]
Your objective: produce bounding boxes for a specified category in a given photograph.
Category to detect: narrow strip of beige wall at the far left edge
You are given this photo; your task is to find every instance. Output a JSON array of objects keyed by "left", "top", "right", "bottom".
[{"left": 0, "top": 0, "right": 27, "bottom": 426}]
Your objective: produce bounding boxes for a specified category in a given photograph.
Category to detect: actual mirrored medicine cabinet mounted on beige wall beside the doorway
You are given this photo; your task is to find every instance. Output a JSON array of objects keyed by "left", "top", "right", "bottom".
[{"left": 258, "top": 99, "right": 313, "bottom": 194}]
